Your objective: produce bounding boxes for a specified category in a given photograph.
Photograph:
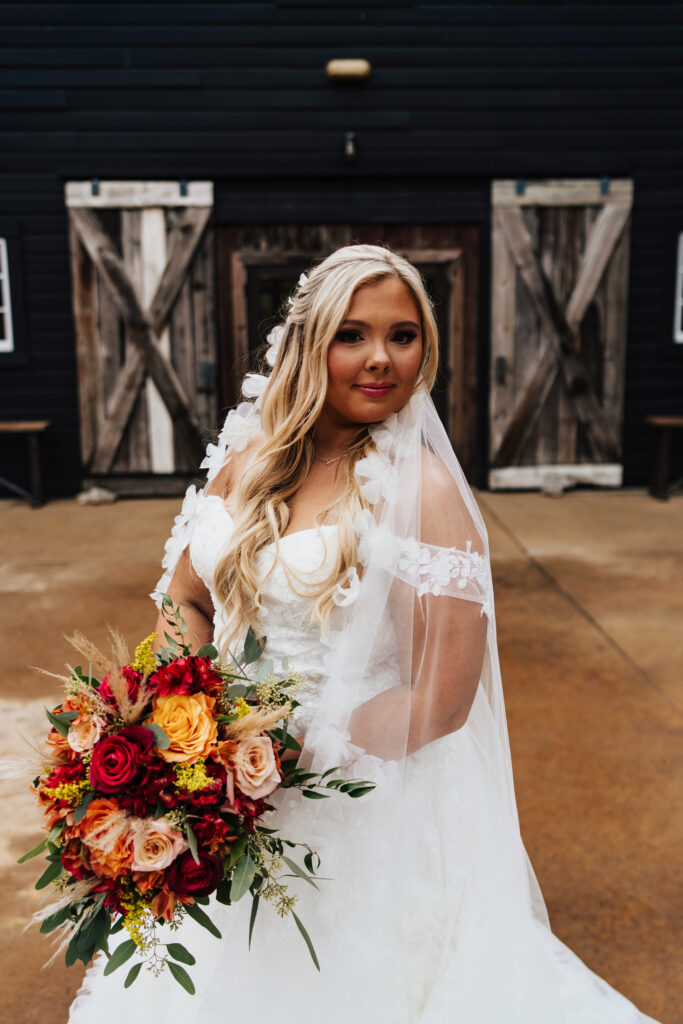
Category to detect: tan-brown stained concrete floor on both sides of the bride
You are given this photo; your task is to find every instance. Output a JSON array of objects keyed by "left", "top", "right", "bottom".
[{"left": 0, "top": 490, "right": 683, "bottom": 1024}]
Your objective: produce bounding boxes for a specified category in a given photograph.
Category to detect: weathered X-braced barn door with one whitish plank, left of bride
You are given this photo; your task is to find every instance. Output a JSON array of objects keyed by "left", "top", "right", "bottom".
[{"left": 66, "top": 181, "right": 217, "bottom": 494}]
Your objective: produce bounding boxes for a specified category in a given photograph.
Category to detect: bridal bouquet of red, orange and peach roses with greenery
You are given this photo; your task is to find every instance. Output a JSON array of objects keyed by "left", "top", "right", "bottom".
[{"left": 20, "top": 595, "right": 373, "bottom": 993}]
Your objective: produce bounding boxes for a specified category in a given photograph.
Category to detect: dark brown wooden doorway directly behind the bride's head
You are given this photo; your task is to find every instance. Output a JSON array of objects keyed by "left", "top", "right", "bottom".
[{"left": 217, "top": 224, "right": 478, "bottom": 479}]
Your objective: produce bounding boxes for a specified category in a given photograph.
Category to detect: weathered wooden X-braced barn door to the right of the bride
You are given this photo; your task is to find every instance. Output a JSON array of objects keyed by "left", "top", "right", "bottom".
[{"left": 488, "top": 179, "right": 633, "bottom": 489}]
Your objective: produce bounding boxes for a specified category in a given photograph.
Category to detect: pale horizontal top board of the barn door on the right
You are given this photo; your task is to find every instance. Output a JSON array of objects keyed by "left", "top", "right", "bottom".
[{"left": 490, "top": 178, "right": 633, "bottom": 208}]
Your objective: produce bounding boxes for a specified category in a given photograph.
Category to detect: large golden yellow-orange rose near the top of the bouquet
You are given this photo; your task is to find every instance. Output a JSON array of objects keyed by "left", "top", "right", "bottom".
[{"left": 146, "top": 693, "right": 218, "bottom": 762}]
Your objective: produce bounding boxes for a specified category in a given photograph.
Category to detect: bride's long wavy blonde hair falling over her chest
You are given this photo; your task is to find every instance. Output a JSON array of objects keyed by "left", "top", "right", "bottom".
[{"left": 214, "top": 245, "right": 438, "bottom": 652}]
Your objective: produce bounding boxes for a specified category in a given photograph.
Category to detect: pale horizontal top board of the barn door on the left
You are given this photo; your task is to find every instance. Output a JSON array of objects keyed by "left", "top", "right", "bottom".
[{"left": 65, "top": 181, "right": 213, "bottom": 209}]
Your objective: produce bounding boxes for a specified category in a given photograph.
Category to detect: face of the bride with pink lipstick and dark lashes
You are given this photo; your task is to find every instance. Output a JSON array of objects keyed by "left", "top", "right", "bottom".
[{"left": 324, "top": 278, "right": 423, "bottom": 427}]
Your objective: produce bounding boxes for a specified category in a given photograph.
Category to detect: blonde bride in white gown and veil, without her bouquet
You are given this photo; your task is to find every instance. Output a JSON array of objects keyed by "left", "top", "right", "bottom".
[{"left": 70, "top": 245, "right": 651, "bottom": 1024}]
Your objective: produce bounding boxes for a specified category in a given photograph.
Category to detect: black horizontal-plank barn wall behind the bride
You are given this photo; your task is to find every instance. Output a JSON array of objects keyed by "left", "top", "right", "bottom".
[{"left": 0, "top": 0, "right": 683, "bottom": 496}]
